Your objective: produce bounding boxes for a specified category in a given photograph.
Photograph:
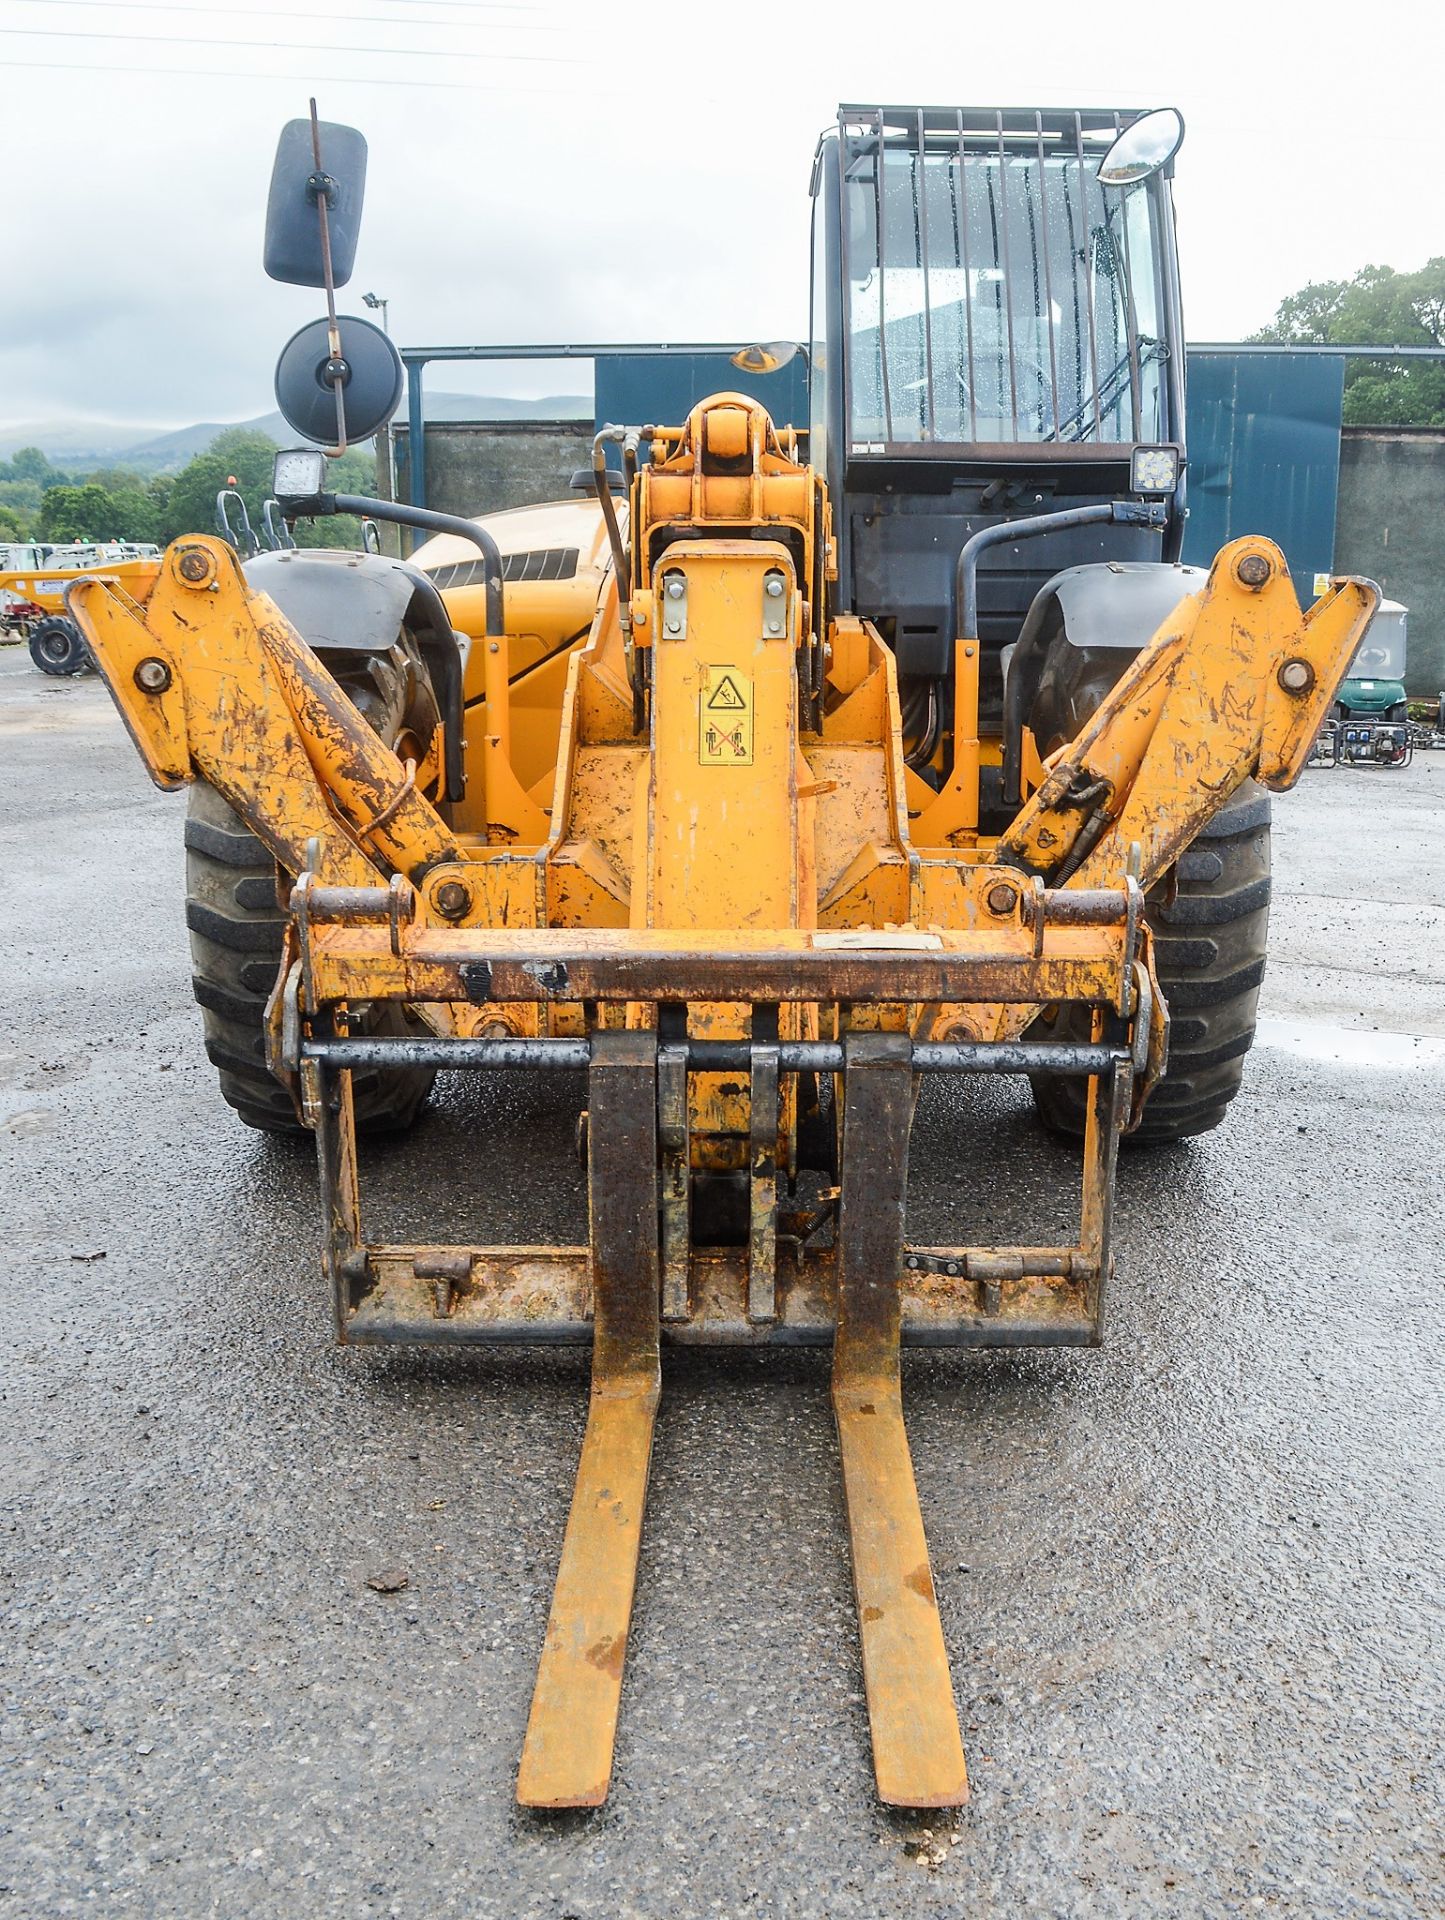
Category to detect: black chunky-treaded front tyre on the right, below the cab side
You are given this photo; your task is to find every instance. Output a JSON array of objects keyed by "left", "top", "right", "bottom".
[{"left": 1032, "top": 780, "right": 1270, "bottom": 1146}]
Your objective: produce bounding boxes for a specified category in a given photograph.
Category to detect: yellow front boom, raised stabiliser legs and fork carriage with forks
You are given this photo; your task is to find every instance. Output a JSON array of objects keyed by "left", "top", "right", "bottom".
[{"left": 69, "top": 385, "right": 1374, "bottom": 1807}]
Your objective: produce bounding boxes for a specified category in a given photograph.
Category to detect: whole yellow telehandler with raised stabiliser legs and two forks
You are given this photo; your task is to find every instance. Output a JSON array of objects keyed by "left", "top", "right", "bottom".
[{"left": 67, "top": 108, "right": 1378, "bottom": 1807}]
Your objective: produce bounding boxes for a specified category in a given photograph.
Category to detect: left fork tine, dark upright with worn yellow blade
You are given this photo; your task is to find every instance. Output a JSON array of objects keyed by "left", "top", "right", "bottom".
[{"left": 516, "top": 1031, "right": 662, "bottom": 1807}]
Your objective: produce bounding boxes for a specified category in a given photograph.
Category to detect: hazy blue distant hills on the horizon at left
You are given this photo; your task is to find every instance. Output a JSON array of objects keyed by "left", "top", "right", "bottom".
[{"left": 0, "top": 388, "right": 593, "bottom": 474}]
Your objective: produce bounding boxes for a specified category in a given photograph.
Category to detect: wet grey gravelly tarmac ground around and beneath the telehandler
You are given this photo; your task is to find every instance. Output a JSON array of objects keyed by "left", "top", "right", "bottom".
[{"left": 0, "top": 649, "right": 1445, "bottom": 1920}]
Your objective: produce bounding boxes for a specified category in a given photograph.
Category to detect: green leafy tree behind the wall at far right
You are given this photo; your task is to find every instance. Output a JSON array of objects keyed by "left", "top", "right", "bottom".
[{"left": 1251, "top": 255, "right": 1445, "bottom": 426}]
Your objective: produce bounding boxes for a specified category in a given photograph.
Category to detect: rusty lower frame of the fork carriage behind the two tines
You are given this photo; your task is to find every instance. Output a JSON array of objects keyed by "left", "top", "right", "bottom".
[{"left": 312, "top": 1036, "right": 1136, "bottom": 1346}]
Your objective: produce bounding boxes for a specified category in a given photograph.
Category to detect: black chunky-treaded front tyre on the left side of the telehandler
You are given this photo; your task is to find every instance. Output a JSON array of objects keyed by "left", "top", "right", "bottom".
[{"left": 186, "top": 780, "right": 436, "bottom": 1133}]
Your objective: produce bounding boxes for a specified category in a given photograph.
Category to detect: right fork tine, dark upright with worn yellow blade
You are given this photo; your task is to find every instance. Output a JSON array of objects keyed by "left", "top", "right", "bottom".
[{"left": 833, "top": 1033, "right": 969, "bottom": 1807}]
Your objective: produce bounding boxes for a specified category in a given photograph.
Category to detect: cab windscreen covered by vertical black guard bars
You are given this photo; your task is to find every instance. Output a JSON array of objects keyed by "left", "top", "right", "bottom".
[{"left": 841, "top": 142, "right": 1167, "bottom": 453}]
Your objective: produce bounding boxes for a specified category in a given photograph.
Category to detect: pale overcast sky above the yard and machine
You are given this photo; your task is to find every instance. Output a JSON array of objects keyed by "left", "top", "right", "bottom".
[{"left": 0, "top": 0, "right": 1445, "bottom": 426}]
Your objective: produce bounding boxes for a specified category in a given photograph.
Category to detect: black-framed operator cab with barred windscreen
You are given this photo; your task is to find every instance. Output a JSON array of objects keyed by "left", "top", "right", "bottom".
[{"left": 810, "top": 106, "right": 1184, "bottom": 771}]
